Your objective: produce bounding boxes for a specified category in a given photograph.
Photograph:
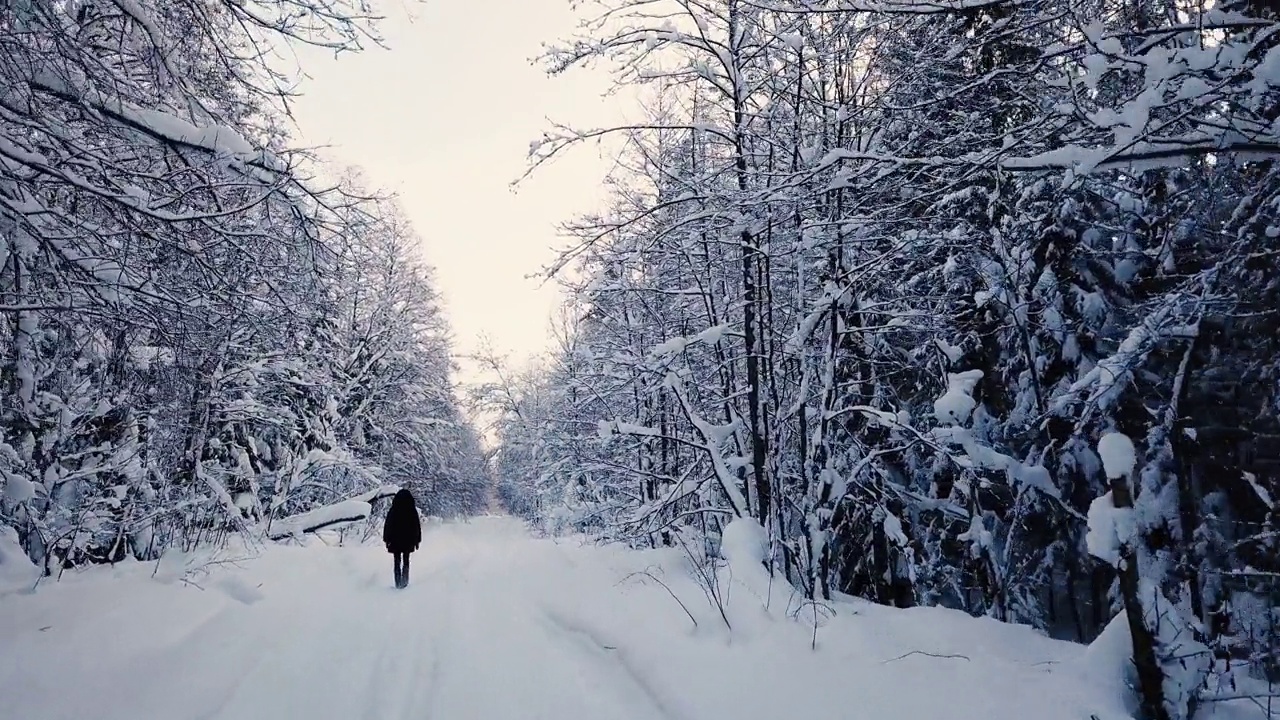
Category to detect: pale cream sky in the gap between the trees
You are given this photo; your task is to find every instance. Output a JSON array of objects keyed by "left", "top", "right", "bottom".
[{"left": 294, "top": 0, "right": 627, "bottom": 380}]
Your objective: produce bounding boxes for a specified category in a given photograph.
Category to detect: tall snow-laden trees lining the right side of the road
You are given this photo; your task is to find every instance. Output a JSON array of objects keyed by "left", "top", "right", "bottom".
[{"left": 489, "top": 0, "right": 1280, "bottom": 719}]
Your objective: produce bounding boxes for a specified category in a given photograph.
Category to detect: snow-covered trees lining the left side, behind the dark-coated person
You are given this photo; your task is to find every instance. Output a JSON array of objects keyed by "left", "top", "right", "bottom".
[{"left": 0, "top": 0, "right": 488, "bottom": 570}]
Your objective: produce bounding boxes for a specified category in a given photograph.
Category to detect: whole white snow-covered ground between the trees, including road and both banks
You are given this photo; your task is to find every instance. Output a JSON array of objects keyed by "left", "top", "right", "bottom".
[{"left": 0, "top": 516, "right": 1264, "bottom": 720}]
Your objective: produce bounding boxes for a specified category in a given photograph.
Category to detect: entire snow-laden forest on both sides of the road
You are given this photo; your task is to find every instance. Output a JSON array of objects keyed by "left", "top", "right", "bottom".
[{"left": 0, "top": 0, "right": 1280, "bottom": 720}]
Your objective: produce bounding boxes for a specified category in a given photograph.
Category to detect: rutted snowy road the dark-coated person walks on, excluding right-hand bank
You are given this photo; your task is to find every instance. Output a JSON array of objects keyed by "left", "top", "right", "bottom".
[{"left": 0, "top": 519, "right": 667, "bottom": 720}]
